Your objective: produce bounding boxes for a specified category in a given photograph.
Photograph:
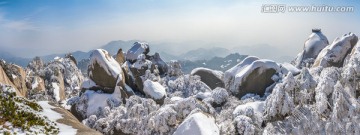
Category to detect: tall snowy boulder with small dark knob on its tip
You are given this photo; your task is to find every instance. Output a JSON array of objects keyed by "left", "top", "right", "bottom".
[{"left": 295, "top": 29, "right": 329, "bottom": 68}]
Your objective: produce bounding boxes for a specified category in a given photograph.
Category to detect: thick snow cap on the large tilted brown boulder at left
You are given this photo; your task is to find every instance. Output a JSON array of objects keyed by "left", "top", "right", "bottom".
[{"left": 89, "top": 49, "right": 122, "bottom": 78}]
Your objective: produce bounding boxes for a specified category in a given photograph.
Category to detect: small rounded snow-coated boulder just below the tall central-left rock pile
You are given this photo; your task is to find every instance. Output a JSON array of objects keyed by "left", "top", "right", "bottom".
[{"left": 144, "top": 80, "right": 166, "bottom": 104}]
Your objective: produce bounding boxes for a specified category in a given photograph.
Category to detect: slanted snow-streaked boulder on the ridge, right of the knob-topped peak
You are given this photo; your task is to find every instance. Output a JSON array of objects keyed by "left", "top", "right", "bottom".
[{"left": 313, "top": 32, "right": 358, "bottom": 67}]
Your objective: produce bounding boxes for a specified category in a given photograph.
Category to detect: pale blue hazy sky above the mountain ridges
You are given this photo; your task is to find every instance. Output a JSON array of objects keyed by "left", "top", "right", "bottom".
[{"left": 0, "top": 0, "right": 360, "bottom": 57}]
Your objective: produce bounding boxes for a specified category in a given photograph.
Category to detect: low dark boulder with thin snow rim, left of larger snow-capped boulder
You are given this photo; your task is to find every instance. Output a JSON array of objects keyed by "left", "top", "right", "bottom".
[{"left": 190, "top": 68, "right": 225, "bottom": 89}]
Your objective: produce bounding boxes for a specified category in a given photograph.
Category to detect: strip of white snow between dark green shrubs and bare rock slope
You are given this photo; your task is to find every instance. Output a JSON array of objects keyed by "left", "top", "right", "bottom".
[{"left": 37, "top": 101, "right": 77, "bottom": 135}]
